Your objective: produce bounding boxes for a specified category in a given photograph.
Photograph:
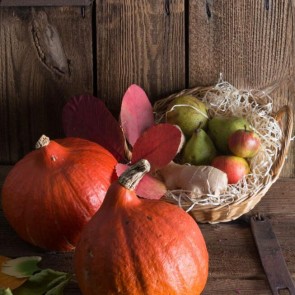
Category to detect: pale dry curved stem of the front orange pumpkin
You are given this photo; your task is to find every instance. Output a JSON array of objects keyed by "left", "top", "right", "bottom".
[{"left": 118, "top": 159, "right": 151, "bottom": 190}]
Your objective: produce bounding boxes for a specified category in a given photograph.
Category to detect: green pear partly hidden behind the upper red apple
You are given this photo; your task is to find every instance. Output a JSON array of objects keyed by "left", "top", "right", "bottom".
[{"left": 208, "top": 116, "right": 249, "bottom": 154}]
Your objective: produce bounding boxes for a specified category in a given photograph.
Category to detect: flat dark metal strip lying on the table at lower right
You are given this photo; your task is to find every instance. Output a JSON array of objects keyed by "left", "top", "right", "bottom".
[{"left": 250, "top": 215, "right": 295, "bottom": 295}]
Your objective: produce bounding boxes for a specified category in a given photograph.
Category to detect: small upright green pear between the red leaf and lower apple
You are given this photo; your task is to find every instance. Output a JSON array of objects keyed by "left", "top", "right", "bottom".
[{"left": 182, "top": 128, "right": 217, "bottom": 165}]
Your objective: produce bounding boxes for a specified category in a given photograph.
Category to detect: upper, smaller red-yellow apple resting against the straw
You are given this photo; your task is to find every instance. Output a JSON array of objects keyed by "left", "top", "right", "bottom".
[{"left": 228, "top": 128, "right": 261, "bottom": 158}]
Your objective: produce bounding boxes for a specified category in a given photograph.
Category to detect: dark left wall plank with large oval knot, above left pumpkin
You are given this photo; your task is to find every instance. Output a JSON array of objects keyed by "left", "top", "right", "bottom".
[{"left": 0, "top": 7, "right": 93, "bottom": 164}]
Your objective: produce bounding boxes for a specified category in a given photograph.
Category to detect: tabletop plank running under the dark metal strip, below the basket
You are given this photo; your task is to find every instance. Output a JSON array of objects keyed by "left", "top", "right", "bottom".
[{"left": 200, "top": 215, "right": 295, "bottom": 279}]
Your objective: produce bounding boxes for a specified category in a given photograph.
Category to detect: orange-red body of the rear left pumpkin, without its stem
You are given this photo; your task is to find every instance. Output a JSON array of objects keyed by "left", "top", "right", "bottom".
[{"left": 2, "top": 138, "right": 117, "bottom": 251}]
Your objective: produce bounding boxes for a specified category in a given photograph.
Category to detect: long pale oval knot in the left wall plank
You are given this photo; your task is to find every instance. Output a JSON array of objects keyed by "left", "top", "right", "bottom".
[{"left": 31, "top": 9, "right": 71, "bottom": 78}]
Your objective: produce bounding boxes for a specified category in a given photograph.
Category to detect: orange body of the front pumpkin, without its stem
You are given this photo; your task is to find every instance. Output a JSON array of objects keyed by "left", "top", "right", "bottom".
[{"left": 74, "top": 182, "right": 208, "bottom": 295}]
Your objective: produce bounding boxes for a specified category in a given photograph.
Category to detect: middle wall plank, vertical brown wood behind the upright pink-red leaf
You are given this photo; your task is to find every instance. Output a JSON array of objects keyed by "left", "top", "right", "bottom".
[{"left": 96, "top": 0, "right": 185, "bottom": 114}]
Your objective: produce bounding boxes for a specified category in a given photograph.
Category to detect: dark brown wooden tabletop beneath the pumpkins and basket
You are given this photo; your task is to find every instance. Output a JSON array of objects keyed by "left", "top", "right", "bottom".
[{"left": 0, "top": 166, "right": 295, "bottom": 295}]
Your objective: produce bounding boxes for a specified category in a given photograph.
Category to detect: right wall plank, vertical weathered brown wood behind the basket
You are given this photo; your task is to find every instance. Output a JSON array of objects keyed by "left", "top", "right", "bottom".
[{"left": 188, "top": 0, "right": 295, "bottom": 177}]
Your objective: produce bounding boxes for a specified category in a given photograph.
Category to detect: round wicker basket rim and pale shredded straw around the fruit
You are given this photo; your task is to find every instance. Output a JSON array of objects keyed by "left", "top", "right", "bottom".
[{"left": 154, "top": 81, "right": 293, "bottom": 223}]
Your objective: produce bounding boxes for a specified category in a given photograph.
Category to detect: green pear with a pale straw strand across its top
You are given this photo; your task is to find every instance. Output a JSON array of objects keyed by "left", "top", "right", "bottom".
[{"left": 166, "top": 95, "right": 208, "bottom": 138}]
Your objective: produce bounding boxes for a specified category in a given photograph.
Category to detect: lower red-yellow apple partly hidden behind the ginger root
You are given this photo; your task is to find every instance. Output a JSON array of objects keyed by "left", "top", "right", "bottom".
[{"left": 211, "top": 156, "right": 250, "bottom": 184}]
